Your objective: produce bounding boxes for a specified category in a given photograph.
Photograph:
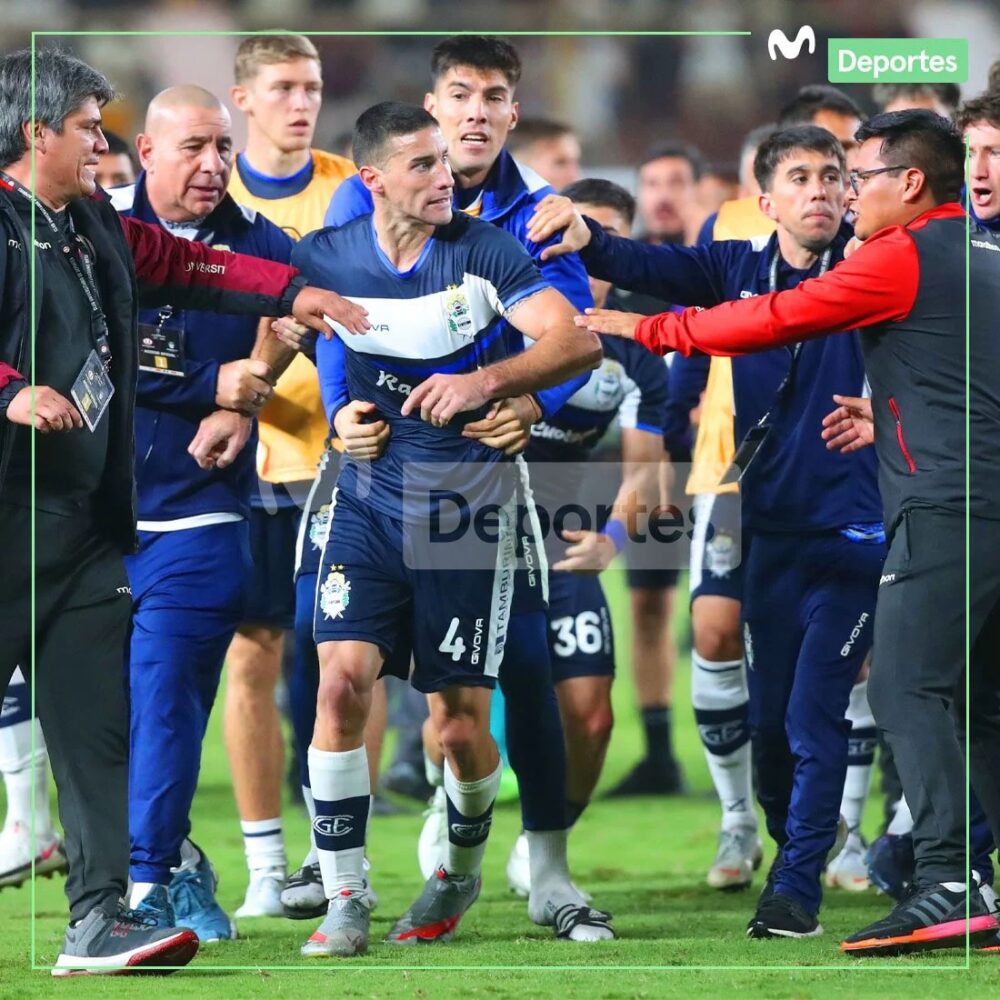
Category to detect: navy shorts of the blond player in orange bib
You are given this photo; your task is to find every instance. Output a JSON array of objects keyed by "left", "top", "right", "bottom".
[{"left": 243, "top": 506, "right": 300, "bottom": 629}]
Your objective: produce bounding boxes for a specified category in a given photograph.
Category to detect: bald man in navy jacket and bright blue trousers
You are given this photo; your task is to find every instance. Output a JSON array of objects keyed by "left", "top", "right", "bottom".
[{"left": 111, "top": 86, "right": 292, "bottom": 941}]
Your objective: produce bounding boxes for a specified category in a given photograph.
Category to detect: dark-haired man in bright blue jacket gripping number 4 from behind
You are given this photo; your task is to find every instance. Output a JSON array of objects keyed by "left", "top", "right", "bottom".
[{"left": 327, "top": 35, "right": 605, "bottom": 924}]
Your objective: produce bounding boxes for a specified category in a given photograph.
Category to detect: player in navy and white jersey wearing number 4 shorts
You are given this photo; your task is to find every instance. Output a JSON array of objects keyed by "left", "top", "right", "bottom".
[{"left": 293, "top": 102, "right": 600, "bottom": 956}]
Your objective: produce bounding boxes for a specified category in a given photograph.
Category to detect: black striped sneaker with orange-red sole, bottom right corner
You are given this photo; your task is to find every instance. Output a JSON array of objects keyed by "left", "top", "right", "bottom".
[{"left": 840, "top": 883, "right": 1000, "bottom": 955}]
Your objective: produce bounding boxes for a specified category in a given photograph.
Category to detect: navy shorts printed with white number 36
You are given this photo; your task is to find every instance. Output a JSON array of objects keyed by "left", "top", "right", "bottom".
[{"left": 549, "top": 572, "right": 615, "bottom": 684}]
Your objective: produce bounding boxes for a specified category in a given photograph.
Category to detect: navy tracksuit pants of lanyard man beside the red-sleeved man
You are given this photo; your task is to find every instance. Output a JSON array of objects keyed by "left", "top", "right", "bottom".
[{"left": 743, "top": 531, "right": 885, "bottom": 913}]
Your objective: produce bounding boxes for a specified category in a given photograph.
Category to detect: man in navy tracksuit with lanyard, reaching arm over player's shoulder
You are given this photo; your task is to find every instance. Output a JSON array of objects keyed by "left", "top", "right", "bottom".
[{"left": 533, "top": 126, "right": 885, "bottom": 937}]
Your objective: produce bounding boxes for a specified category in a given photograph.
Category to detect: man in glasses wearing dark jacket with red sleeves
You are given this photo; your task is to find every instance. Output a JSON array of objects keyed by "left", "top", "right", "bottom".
[{"left": 592, "top": 110, "right": 1000, "bottom": 955}]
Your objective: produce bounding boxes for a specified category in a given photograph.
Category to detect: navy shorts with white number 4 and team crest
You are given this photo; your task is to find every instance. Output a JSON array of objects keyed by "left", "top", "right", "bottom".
[{"left": 313, "top": 491, "right": 517, "bottom": 693}]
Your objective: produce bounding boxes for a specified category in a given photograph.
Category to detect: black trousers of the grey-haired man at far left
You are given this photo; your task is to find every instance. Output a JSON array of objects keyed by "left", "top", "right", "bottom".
[{"left": 0, "top": 502, "right": 132, "bottom": 920}]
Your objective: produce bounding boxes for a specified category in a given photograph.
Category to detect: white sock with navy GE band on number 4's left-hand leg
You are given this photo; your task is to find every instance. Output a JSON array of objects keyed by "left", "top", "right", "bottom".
[{"left": 309, "top": 746, "right": 371, "bottom": 899}]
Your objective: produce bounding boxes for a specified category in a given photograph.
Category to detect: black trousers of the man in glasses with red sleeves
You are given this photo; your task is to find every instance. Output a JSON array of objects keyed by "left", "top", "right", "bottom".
[{"left": 868, "top": 508, "right": 1000, "bottom": 883}]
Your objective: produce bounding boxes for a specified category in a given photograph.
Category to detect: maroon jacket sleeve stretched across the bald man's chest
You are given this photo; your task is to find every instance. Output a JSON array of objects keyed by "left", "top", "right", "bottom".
[{"left": 119, "top": 216, "right": 305, "bottom": 316}]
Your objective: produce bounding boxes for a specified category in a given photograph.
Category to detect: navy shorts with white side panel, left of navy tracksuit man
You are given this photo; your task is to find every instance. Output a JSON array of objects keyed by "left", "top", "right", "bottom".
[{"left": 691, "top": 493, "right": 746, "bottom": 602}]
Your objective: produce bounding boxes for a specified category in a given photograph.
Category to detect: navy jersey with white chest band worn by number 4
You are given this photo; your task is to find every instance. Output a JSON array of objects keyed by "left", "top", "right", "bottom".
[{"left": 292, "top": 213, "right": 549, "bottom": 517}]
